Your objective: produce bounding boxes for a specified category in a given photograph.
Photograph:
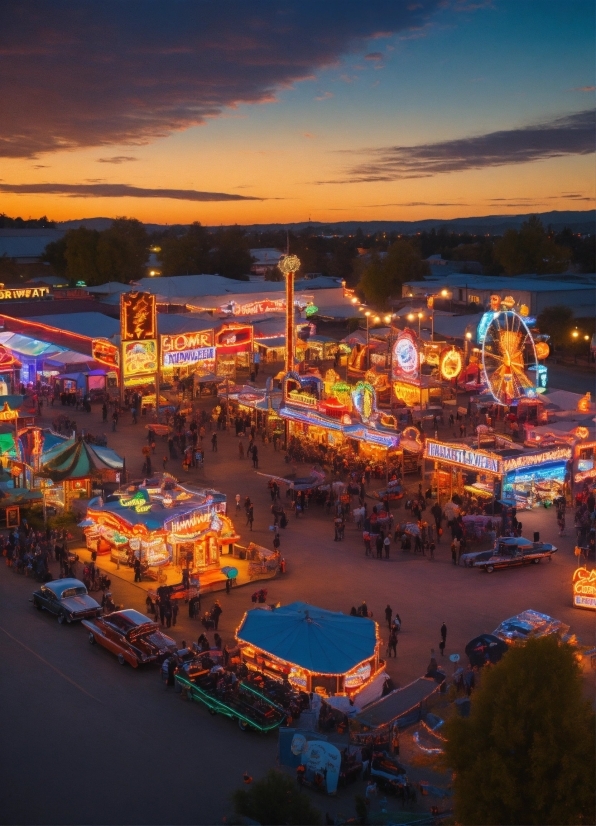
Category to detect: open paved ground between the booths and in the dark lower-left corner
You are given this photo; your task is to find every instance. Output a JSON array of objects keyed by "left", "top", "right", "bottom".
[{"left": 0, "top": 388, "right": 594, "bottom": 824}]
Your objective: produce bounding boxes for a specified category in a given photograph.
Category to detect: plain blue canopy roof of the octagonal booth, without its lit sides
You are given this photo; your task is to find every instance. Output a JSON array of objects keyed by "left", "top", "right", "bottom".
[{"left": 236, "top": 602, "right": 377, "bottom": 675}]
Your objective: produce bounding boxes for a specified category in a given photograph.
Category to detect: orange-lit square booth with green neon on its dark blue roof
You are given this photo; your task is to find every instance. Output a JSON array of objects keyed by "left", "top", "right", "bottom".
[{"left": 85, "top": 474, "right": 240, "bottom": 579}]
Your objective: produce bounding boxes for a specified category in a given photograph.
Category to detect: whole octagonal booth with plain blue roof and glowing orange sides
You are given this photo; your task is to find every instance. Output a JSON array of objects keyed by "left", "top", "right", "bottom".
[{"left": 236, "top": 602, "right": 384, "bottom": 701}]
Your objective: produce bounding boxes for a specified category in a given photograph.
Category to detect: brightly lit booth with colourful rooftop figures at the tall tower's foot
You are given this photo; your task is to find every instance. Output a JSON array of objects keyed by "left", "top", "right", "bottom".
[{"left": 279, "top": 372, "right": 400, "bottom": 459}]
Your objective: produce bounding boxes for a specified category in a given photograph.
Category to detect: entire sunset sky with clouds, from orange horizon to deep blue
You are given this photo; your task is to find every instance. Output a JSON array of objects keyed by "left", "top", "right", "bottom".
[{"left": 0, "top": 0, "right": 596, "bottom": 225}]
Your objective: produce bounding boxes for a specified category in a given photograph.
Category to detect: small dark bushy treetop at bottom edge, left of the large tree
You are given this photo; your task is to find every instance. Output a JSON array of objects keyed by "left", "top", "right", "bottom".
[{"left": 232, "top": 769, "right": 321, "bottom": 826}]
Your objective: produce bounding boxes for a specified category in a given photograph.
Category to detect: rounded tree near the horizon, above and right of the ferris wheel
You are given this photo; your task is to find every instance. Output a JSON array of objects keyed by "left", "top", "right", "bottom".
[{"left": 494, "top": 215, "right": 571, "bottom": 275}]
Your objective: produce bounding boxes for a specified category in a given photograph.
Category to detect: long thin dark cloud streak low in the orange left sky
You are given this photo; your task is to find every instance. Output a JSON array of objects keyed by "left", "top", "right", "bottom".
[{"left": 0, "top": 183, "right": 265, "bottom": 201}]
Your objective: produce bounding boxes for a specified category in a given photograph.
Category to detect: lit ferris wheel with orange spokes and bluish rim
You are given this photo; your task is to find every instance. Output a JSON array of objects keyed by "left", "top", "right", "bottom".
[{"left": 482, "top": 310, "right": 538, "bottom": 405}]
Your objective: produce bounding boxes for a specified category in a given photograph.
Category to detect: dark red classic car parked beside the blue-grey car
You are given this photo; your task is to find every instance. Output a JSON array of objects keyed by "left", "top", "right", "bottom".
[{"left": 83, "top": 608, "right": 177, "bottom": 668}]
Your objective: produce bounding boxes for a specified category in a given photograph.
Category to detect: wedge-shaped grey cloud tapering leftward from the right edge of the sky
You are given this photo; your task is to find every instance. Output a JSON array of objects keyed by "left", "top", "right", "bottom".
[{"left": 336, "top": 110, "right": 596, "bottom": 183}]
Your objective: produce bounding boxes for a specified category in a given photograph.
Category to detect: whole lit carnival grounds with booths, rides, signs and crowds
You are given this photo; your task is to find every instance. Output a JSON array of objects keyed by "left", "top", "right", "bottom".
[{"left": 0, "top": 255, "right": 596, "bottom": 823}]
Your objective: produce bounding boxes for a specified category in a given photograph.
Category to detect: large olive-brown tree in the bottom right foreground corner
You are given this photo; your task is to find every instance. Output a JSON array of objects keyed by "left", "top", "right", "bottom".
[{"left": 445, "top": 636, "right": 595, "bottom": 824}]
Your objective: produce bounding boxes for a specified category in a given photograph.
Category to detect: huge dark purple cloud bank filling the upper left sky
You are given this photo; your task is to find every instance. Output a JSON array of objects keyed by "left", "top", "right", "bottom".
[{"left": 0, "top": 0, "right": 441, "bottom": 157}]
